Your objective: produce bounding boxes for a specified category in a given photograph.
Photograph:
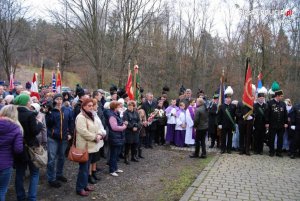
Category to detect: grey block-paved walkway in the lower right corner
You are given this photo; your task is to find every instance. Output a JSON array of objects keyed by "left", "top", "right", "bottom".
[{"left": 181, "top": 153, "right": 300, "bottom": 201}]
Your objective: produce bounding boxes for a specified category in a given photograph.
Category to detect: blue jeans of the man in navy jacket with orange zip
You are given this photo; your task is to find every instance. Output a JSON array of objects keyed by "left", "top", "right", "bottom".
[{"left": 47, "top": 137, "right": 68, "bottom": 182}]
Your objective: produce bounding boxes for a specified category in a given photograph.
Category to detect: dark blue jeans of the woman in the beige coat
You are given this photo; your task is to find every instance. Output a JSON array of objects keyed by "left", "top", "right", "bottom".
[{"left": 76, "top": 157, "right": 91, "bottom": 192}]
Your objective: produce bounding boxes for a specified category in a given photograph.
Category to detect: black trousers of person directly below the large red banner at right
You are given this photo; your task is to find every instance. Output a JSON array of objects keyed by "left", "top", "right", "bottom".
[{"left": 239, "top": 120, "right": 253, "bottom": 154}]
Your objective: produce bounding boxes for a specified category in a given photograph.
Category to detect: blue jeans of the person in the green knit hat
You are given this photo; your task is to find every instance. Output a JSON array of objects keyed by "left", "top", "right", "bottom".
[{"left": 15, "top": 161, "right": 39, "bottom": 201}]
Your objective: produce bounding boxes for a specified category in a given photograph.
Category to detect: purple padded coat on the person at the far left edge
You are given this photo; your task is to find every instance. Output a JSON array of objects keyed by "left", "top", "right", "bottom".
[{"left": 0, "top": 118, "right": 23, "bottom": 170}]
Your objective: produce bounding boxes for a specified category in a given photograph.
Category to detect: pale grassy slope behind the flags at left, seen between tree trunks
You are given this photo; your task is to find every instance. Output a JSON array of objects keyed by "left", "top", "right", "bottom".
[{"left": 15, "top": 66, "right": 82, "bottom": 89}]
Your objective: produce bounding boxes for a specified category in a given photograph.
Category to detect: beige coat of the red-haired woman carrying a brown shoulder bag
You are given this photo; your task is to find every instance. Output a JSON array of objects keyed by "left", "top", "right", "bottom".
[{"left": 75, "top": 111, "right": 104, "bottom": 153}]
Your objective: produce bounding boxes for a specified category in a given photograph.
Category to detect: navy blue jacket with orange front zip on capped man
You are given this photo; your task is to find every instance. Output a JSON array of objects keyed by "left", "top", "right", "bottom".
[{"left": 46, "top": 106, "right": 74, "bottom": 140}]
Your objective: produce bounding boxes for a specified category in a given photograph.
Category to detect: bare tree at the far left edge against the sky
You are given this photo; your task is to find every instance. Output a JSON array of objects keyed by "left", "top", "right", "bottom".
[{"left": 0, "top": 0, "right": 26, "bottom": 80}]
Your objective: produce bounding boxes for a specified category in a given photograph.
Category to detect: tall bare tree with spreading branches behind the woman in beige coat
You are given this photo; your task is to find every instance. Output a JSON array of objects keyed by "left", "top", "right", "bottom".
[{"left": 56, "top": 0, "right": 110, "bottom": 88}]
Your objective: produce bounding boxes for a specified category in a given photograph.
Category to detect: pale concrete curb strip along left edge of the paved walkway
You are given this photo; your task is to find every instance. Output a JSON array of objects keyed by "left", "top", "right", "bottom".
[{"left": 179, "top": 154, "right": 220, "bottom": 201}]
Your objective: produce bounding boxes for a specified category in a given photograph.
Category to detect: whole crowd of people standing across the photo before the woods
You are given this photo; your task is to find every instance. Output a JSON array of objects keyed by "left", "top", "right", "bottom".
[{"left": 0, "top": 81, "right": 300, "bottom": 201}]
